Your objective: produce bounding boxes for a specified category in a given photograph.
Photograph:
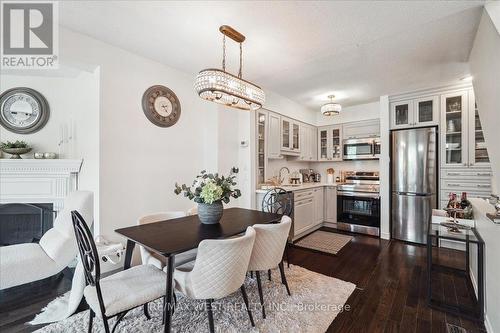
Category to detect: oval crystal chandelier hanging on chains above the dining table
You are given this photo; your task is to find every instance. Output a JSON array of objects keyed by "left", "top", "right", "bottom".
[{"left": 194, "top": 25, "right": 266, "bottom": 110}]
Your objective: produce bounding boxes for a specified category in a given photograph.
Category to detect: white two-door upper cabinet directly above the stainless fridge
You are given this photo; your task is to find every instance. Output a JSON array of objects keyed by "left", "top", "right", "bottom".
[{"left": 391, "top": 96, "right": 439, "bottom": 129}]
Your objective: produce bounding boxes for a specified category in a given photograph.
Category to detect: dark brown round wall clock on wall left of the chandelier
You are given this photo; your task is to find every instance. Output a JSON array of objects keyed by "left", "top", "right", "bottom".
[{"left": 142, "top": 85, "right": 181, "bottom": 127}]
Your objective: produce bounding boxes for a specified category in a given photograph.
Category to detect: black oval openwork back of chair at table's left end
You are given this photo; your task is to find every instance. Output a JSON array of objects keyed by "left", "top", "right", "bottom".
[{"left": 71, "top": 210, "right": 101, "bottom": 286}]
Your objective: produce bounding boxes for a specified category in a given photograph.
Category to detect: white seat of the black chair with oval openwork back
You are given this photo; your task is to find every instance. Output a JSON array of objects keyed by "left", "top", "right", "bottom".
[{"left": 83, "top": 265, "right": 166, "bottom": 317}]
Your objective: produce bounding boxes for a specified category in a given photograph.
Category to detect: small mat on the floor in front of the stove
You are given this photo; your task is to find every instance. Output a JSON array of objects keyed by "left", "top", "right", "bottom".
[{"left": 294, "top": 230, "right": 353, "bottom": 254}]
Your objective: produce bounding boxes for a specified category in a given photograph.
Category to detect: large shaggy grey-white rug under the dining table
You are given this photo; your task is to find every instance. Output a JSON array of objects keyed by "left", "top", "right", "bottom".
[{"left": 37, "top": 265, "right": 356, "bottom": 333}]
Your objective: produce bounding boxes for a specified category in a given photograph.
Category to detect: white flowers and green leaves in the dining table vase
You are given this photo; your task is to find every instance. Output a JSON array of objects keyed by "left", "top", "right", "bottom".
[{"left": 174, "top": 167, "right": 241, "bottom": 205}]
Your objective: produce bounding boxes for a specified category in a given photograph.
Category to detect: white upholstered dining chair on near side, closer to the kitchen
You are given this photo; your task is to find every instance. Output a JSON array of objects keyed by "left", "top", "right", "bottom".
[{"left": 248, "top": 215, "right": 292, "bottom": 318}]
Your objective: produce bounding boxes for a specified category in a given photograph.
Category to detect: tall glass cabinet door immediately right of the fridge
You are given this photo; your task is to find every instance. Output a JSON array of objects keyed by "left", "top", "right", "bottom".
[{"left": 441, "top": 91, "right": 469, "bottom": 167}]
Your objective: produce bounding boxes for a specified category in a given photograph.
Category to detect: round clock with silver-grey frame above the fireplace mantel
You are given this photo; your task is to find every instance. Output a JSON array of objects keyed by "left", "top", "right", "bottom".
[{"left": 0, "top": 87, "right": 50, "bottom": 134}]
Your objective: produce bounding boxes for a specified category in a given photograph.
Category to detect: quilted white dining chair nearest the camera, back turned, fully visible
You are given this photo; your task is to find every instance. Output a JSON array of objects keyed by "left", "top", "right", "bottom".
[{"left": 174, "top": 227, "right": 255, "bottom": 332}]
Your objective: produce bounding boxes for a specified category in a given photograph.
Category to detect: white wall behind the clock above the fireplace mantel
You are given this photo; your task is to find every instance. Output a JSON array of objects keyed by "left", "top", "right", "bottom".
[{"left": 0, "top": 68, "right": 99, "bottom": 226}]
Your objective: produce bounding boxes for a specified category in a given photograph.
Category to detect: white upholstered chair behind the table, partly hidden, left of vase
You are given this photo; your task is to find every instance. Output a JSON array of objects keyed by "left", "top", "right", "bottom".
[{"left": 137, "top": 211, "right": 197, "bottom": 269}]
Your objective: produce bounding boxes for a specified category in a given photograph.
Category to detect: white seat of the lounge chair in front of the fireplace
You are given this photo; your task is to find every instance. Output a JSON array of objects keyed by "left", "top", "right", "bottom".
[{"left": 0, "top": 243, "right": 65, "bottom": 289}]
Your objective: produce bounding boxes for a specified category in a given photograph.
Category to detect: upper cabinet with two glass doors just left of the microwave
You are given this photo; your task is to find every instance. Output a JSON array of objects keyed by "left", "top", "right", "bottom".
[{"left": 317, "top": 125, "right": 342, "bottom": 161}]
